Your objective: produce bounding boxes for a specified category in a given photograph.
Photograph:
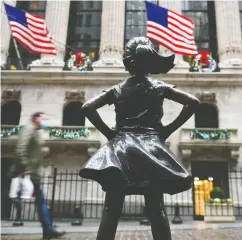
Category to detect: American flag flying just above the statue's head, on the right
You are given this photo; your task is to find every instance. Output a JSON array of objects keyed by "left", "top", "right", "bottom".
[{"left": 145, "top": 2, "right": 198, "bottom": 55}]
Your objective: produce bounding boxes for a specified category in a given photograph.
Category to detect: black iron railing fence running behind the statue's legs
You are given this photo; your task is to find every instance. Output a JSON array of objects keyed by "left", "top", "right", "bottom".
[{"left": 8, "top": 169, "right": 242, "bottom": 221}]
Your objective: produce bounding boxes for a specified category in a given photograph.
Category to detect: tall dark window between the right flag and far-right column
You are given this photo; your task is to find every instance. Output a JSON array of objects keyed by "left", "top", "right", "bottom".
[{"left": 182, "top": 0, "right": 218, "bottom": 61}]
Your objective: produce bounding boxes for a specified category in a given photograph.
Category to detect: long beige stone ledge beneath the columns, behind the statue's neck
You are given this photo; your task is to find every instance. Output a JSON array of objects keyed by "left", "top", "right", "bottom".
[{"left": 1, "top": 70, "right": 242, "bottom": 87}]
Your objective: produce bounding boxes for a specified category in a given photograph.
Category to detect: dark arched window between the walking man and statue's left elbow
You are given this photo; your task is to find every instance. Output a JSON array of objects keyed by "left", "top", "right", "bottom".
[{"left": 62, "top": 101, "right": 85, "bottom": 126}]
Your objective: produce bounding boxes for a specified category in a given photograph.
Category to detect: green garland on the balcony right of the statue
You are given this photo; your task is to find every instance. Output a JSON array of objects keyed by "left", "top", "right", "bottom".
[{"left": 190, "top": 129, "right": 230, "bottom": 140}]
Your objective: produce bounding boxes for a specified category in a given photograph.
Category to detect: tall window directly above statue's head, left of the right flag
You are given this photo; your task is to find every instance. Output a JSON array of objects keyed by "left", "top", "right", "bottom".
[{"left": 124, "top": 1, "right": 159, "bottom": 50}]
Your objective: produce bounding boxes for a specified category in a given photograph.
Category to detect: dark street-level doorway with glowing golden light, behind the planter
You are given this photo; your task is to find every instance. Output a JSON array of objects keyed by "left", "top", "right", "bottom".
[{"left": 192, "top": 161, "right": 229, "bottom": 220}]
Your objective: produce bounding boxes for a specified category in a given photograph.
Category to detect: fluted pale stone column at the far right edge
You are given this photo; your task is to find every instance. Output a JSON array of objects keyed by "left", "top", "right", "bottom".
[{"left": 215, "top": 0, "right": 242, "bottom": 72}]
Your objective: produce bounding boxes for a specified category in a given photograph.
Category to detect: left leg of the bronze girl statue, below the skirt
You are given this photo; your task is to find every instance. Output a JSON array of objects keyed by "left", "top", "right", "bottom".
[{"left": 97, "top": 188, "right": 125, "bottom": 240}]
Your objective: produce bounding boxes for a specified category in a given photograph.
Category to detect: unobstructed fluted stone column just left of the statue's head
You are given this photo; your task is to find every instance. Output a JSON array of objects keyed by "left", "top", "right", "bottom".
[{"left": 93, "top": 0, "right": 125, "bottom": 71}]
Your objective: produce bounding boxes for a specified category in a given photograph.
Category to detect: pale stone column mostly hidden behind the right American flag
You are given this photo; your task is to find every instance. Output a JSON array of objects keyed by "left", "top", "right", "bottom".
[{"left": 159, "top": 0, "right": 189, "bottom": 72}]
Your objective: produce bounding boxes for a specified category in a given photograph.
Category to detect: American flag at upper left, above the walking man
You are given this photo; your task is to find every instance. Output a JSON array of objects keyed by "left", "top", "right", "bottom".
[{"left": 4, "top": 4, "right": 56, "bottom": 55}]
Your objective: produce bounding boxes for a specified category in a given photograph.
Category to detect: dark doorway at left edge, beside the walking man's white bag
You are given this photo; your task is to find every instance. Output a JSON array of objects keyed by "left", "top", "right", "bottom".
[{"left": 1, "top": 158, "right": 12, "bottom": 220}]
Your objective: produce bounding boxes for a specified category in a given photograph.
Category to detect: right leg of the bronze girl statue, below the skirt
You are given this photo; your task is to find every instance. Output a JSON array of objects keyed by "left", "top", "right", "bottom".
[{"left": 145, "top": 191, "right": 171, "bottom": 240}]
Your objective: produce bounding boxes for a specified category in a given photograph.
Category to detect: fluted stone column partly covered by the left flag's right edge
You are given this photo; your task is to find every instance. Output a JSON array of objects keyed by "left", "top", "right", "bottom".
[{"left": 30, "top": 0, "right": 70, "bottom": 71}]
